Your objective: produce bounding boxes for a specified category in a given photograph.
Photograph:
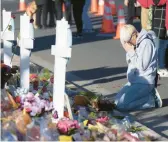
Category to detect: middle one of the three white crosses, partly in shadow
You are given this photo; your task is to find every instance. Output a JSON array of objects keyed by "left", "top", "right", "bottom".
[{"left": 19, "top": 14, "right": 34, "bottom": 90}]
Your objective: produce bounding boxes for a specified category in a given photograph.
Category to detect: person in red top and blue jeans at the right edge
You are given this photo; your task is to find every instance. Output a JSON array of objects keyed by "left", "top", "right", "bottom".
[{"left": 152, "top": 0, "right": 168, "bottom": 77}]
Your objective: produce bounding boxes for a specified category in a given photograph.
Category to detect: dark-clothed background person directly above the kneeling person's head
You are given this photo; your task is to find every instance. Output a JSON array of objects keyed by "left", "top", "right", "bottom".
[{"left": 124, "top": 0, "right": 141, "bottom": 25}]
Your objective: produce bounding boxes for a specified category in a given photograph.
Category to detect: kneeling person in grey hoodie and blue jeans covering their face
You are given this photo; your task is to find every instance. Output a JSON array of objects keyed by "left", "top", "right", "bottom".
[{"left": 115, "top": 25, "right": 162, "bottom": 111}]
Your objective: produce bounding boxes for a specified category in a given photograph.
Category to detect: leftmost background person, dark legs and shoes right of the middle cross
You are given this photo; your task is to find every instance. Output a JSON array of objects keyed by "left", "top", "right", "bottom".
[{"left": 35, "top": 0, "right": 47, "bottom": 29}]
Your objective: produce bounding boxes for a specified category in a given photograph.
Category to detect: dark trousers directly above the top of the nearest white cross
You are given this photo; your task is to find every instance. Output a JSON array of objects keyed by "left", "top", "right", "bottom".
[{"left": 55, "top": 0, "right": 71, "bottom": 23}]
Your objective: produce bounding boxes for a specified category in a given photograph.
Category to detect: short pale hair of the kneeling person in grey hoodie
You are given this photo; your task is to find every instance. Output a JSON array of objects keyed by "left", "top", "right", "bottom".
[{"left": 120, "top": 24, "right": 137, "bottom": 43}]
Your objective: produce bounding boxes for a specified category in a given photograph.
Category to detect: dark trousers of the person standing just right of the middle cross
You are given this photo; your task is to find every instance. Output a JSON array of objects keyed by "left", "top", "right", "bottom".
[{"left": 36, "top": 4, "right": 47, "bottom": 26}]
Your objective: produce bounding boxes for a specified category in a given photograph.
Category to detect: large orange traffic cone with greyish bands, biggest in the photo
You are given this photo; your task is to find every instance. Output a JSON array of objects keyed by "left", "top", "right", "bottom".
[{"left": 100, "top": 0, "right": 115, "bottom": 33}]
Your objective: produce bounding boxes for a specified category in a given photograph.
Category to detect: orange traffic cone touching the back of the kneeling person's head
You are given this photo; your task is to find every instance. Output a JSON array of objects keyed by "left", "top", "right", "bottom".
[{"left": 113, "top": 6, "right": 126, "bottom": 39}]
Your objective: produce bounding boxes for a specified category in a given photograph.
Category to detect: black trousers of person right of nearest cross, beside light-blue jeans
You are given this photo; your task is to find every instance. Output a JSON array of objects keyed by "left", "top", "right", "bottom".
[{"left": 72, "top": 0, "right": 85, "bottom": 33}]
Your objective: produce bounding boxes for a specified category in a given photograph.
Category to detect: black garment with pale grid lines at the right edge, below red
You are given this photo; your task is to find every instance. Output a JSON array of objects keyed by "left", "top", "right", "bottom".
[{"left": 152, "top": 0, "right": 167, "bottom": 39}]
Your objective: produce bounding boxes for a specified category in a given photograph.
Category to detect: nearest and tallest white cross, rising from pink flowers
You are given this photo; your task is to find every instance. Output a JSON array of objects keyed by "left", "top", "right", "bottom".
[{"left": 51, "top": 18, "right": 72, "bottom": 122}]
